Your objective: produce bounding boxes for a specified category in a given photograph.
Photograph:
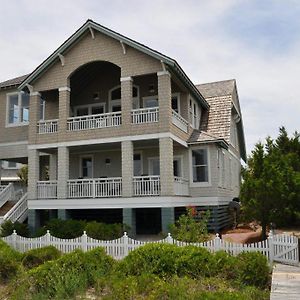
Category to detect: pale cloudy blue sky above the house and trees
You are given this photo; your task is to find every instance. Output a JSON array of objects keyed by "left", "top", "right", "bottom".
[{"left": 0, "top": 0, "right": 300, "bottom": 153}]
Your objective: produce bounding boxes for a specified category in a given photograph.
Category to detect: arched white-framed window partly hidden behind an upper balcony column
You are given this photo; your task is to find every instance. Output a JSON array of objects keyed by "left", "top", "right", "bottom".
[{"left": 109, "top": 85, "right": 140, "bottom": 112}]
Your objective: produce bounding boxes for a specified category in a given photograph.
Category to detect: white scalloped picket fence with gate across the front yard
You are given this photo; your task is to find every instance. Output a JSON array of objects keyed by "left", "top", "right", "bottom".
[{"left": 2, "top": 231, "right": 299, "bottom": 264}]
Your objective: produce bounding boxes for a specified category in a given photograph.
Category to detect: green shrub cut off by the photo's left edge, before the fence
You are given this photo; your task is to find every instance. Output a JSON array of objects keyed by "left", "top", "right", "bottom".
[{"left": 0, "top": 240, "right": 22, "bottom": 283}]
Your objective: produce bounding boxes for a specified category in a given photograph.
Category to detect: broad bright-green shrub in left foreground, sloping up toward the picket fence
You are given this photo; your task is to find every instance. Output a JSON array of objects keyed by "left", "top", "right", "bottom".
[{"left": 28, "top": 248, "right": 114, "bottom": 299}]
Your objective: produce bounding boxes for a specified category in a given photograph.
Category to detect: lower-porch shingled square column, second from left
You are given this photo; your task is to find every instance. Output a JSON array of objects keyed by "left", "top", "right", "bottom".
[{"left": 57, "top": 147, "right": 69, "bottom": 199}]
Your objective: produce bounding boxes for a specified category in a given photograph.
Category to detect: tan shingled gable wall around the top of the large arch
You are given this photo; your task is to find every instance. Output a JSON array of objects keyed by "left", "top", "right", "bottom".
[{"left": 32, "top": 32, "right": 162, "bottom": 91}]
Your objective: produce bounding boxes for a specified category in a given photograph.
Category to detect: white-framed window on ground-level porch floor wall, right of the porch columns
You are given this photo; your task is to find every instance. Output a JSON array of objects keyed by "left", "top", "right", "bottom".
[{"left": 192, "top": 149, "right": 208, "bottom": 182}]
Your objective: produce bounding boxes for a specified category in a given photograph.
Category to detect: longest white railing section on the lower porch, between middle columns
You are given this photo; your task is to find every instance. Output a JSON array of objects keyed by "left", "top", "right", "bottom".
[{"left": 68, "top": 177, "right": 122, "bottom": 198}]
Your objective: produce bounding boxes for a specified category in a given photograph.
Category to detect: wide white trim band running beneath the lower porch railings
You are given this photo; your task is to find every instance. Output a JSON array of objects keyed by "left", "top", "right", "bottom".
[{"left": 28, "top": 196, "right": 233, "bottom": 209}]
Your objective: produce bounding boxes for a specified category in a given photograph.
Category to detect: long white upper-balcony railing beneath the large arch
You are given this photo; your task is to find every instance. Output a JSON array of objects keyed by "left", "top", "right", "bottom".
[{"left": 67, "top": 112, "right": 122, "bottom": 131}]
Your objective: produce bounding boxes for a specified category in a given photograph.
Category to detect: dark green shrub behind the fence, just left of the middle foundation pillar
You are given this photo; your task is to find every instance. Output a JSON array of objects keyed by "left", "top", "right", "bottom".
[{"left": 85, "top": 221, "right": 127, "bottom": 240}]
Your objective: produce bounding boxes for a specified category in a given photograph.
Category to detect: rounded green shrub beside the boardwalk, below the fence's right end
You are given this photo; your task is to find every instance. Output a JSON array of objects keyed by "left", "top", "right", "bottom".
[{"left": 237, "top": 252, "right": 270, "bottom": 288}]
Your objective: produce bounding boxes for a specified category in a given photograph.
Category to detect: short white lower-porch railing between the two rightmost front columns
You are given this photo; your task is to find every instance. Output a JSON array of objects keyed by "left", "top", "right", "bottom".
[{"left": 133, "top": 176, "right": 160, "bottom": 196}]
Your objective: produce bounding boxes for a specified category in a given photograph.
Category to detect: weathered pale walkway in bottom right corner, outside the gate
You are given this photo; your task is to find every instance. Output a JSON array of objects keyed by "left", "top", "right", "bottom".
[{"left": 270, "top": 264, "right": 300, "bottom": 300}]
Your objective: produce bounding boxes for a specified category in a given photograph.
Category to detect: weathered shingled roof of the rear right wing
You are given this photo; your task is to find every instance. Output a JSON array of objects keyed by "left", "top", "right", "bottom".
[{"left": 196, "top": 79, "right": 247, "bottom": 162}]
